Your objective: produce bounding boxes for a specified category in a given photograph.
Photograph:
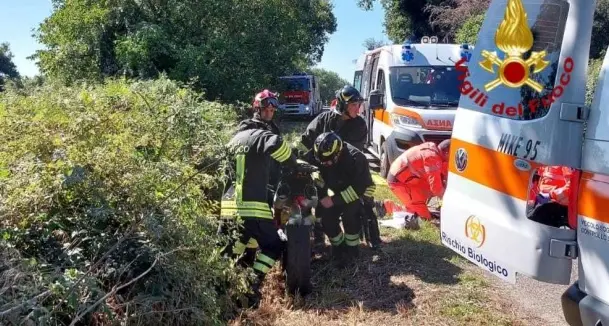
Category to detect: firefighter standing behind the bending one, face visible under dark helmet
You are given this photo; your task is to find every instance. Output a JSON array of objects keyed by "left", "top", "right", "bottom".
[{"left": 297, "top": 85, "right": 381, "bottom": 248}]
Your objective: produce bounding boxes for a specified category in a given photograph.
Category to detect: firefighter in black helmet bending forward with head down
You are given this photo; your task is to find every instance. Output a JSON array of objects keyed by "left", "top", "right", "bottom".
[{"left": 305, "top": 132, "right": 373, "bottom": 267}]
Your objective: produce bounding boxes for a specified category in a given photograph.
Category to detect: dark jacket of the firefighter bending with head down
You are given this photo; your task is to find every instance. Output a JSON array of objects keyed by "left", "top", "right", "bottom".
[{"left": 303, "top": 143, "right": 374, "bottom": 206}]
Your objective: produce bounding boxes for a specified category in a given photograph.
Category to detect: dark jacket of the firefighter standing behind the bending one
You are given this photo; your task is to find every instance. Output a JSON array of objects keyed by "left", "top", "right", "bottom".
[{"left": 300, "top": 110, "right": 368, "bottom": 151}]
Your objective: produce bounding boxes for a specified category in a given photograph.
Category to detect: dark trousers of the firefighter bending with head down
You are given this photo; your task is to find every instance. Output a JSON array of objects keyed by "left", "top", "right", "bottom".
[{"left": 316, "top": 200, "right": 362, "bottom": 247}]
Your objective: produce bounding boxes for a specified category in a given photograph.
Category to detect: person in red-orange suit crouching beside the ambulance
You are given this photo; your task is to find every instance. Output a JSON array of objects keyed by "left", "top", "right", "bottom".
[{"left": 385, "top": 139, "right": 450, "bottom": 220}]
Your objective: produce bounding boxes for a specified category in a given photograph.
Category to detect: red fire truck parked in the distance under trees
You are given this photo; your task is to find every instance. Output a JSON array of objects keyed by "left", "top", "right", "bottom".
[{"left": 279, "top": 73, "right": 323, "bottom": 119}]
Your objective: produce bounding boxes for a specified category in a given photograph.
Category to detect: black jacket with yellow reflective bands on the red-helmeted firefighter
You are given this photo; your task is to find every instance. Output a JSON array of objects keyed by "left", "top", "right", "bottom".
[{"left": 220, "top": 123, "right": 296, "bottom": 219}]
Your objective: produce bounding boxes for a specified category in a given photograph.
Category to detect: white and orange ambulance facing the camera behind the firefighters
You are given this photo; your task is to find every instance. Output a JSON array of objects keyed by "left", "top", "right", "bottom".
[{"left": 353, "top": 36, "right": 472, "bottom": 177}]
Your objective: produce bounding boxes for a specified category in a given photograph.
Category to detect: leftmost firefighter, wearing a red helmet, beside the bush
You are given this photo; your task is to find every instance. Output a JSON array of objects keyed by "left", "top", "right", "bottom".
[{"left": 220, "top": 91, "right": 296, "bottom": 307}]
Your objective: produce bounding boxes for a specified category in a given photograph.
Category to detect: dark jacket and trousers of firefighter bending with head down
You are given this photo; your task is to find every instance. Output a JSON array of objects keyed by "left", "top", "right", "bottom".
[{"left": 305, "top": 141, "right": 374, "bottom": 258}]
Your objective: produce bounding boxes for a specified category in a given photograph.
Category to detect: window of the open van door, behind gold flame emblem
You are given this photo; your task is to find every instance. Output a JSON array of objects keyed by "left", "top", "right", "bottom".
[{"left": 457, "top": 0, "right": 573, "bottom": 120}]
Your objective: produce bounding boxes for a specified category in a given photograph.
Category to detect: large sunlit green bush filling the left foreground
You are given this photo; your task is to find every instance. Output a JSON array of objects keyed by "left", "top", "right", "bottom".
[{"left": 0, "top": 78, "right": 251, "bottom": 325}]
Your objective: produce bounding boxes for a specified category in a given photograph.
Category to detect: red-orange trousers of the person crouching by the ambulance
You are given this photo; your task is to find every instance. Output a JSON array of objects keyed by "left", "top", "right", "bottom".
[{"left": 389, "top": 178, "right": 431, "bottom": 220}]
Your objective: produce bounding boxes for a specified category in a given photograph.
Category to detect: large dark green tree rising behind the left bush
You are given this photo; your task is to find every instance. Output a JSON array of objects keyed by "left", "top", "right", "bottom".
[{"left": 34, "top": 0, "right": 336, "bottom": 101}]
